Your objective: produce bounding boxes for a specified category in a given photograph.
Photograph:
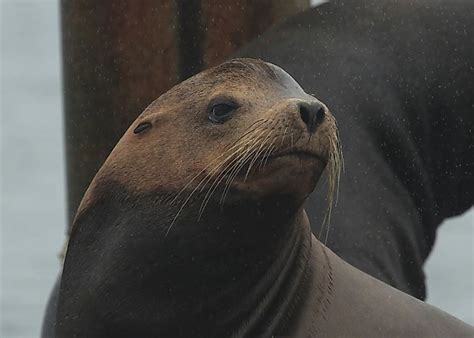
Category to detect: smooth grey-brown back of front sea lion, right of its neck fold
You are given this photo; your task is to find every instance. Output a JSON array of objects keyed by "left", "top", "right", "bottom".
[{"left": 288, "top": 237, "right": 474, "bottom": 337}]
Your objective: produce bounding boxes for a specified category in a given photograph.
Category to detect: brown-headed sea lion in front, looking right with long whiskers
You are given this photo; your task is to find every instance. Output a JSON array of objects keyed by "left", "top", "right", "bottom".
[{"left": 56, "top": 59, "right": 474, "bottom": 337}]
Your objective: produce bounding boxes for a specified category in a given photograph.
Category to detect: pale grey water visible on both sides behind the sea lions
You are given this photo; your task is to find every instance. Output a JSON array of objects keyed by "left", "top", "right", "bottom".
[{"left": 0, "top": 0, "right": 474, "bottom": 338}]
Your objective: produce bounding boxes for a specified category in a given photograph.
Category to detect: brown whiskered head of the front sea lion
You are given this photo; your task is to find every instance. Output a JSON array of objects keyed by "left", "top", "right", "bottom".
[{"left": 78, "top": 59, "right": 340, "bottom": 226}]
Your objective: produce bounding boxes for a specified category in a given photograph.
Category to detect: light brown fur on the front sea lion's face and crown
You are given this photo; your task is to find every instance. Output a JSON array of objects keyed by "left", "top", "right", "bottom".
[{"left": 78, "top": 59, "right": 338, "bottom": 222}]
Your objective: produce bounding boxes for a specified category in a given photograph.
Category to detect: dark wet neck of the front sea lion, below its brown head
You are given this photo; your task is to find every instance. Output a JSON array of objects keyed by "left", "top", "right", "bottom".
[{"left": 59, "top": 184, "right": 311, "bottom": 336}]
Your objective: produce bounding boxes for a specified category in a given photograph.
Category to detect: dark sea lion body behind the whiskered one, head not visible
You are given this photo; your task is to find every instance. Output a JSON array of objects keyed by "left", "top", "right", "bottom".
[{"left": 236, "top": 0, "right": 474, "bottom": 299}]
